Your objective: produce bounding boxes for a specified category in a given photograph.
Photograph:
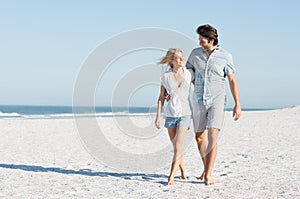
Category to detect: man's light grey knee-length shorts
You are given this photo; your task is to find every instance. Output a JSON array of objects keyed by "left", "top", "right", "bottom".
[{"left": 193, "top": 101, "right": 225, "bottom": 132}]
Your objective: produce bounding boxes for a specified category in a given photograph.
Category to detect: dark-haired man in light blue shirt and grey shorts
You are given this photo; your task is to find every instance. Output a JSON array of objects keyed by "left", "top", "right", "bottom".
[{"left": 186, "top": 25, "right": 241, "bottom": 185}]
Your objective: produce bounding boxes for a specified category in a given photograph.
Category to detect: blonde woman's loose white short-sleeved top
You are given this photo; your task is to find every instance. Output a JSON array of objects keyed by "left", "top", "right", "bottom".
[{"left": 161, "top": 68, "right": 191, "bottom": 117}]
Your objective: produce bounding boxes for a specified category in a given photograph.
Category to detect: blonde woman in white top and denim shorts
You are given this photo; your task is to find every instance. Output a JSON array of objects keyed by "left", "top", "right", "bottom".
[{"left": 155, "top": 48, "right": 191, "bottom": 185}]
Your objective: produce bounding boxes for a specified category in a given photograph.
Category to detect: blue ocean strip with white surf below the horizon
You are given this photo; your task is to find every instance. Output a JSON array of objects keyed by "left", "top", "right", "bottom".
[{"left": 0, "top": 105, "right": 272, "bottom": 119}]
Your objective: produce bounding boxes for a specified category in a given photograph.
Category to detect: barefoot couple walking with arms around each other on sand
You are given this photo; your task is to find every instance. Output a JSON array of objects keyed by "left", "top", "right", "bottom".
[{"left": 155, "top": 25, "right": 241, "bottom": 185}]
